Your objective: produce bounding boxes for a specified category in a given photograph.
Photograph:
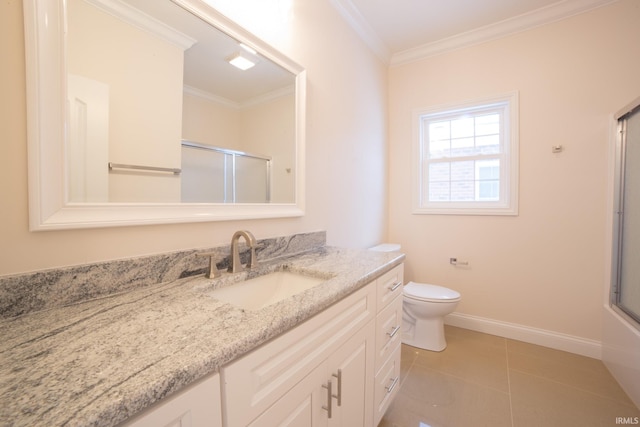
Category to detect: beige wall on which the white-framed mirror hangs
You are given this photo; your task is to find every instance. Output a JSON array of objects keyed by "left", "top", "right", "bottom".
[{"left": 0, "top": 0, "right": 387, "bottom": 275}]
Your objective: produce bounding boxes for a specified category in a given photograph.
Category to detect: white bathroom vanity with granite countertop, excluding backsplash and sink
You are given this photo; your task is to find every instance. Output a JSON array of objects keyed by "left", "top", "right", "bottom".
[{"left": 0, "top": 247, "right": 404, "bottom": 427}]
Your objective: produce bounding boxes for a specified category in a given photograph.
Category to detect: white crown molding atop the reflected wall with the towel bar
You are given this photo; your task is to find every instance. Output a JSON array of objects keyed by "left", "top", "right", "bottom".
[{"left": 85, "top": 0, "right": 197, "bottom": 50}]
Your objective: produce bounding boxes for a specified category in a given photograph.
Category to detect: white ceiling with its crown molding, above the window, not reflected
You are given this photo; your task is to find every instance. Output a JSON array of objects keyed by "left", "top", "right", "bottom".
[{"left": 332, "top": 0, "right": 615, "bottom": 65}]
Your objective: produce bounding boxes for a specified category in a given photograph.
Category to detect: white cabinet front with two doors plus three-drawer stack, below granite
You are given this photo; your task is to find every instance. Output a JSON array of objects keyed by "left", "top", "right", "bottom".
[{"left": 221, "top": 265, "right": 403, "bottom": 427}]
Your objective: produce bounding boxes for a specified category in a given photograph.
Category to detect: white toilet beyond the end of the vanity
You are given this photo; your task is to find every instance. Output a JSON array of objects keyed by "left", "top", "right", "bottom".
[{"left": 371, "top": 243, "right": 460, "bottom": 351}]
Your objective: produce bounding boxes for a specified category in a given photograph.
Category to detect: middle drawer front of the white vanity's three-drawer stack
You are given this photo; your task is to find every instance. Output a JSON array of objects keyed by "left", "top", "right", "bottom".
[{"left": 375, "top": 295, "right": 402, "bottom": 372}]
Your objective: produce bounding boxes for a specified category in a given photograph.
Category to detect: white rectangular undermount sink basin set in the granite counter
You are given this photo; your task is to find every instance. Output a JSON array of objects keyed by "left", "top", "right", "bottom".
[{"left": 209, "top": 271, "right": 327, "bottom": 310}]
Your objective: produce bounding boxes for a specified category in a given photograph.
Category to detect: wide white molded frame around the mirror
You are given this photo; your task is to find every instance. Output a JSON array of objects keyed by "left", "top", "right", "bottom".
[{"left": 24, "top": 0, "right": 306, "bottom": 231}]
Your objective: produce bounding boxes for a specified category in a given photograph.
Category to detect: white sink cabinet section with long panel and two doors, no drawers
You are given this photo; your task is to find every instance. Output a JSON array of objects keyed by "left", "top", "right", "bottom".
[{"left": 221, "top": 285, "right": 376, "bottom": 427}]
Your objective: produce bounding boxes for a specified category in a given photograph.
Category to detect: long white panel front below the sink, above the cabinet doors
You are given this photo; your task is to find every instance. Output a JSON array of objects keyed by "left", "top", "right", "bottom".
[{"left": 221, "top": 283, "right": 376, "bottom": 427}]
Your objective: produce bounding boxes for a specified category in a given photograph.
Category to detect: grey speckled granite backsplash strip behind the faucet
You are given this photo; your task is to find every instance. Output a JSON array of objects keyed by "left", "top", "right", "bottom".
[{"left": 0, "top": 231, "right": 326, "bottom": 318}]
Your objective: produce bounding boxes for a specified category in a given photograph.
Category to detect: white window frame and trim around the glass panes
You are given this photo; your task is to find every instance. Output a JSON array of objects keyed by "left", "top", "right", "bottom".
[{"left": 412, "top": 91, "right": 519, "bottom": 215}]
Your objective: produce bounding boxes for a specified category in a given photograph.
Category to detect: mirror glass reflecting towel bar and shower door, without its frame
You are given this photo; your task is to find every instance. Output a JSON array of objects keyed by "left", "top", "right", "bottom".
[{"left": 66, "top": 0, "right": 296, "bottom": 203}]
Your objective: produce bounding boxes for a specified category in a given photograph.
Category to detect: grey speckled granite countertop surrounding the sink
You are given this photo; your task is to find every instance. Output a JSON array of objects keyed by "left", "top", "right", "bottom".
[{"left": 0, "top": 247, "right": 404, "bottom": 427}]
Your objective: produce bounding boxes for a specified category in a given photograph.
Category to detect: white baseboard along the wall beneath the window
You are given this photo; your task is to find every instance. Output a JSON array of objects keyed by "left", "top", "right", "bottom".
[{"left": 444, "top": 313, "right": 602, "bottom": 360}]
